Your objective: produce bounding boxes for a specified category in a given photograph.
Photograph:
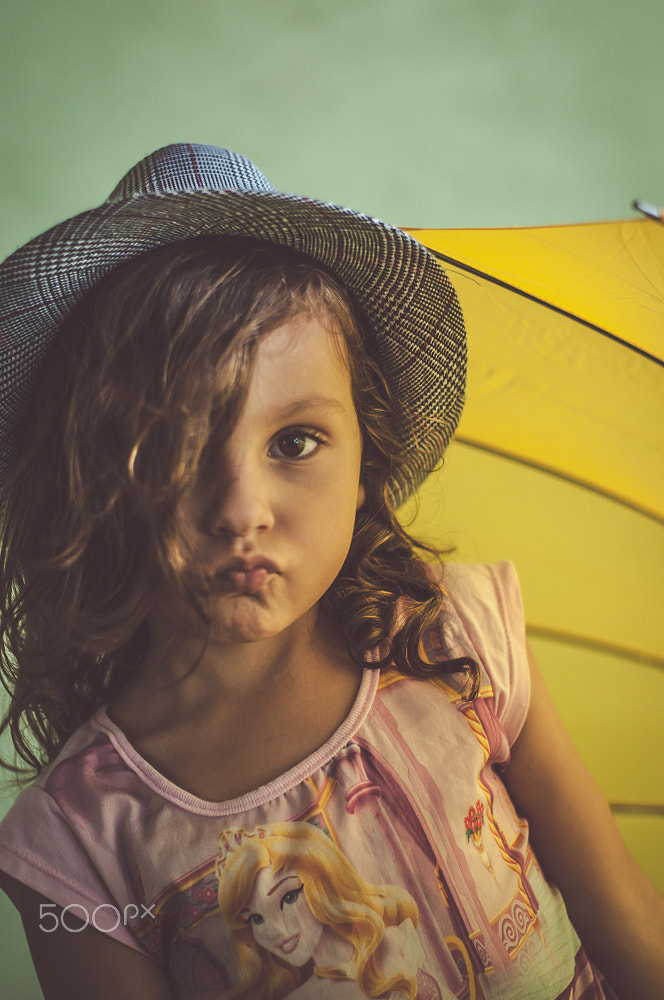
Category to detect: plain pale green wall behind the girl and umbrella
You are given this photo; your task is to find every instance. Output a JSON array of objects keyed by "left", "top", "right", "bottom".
[{"left": 0, "top": 0, "right": 664, "bottom": 1000}]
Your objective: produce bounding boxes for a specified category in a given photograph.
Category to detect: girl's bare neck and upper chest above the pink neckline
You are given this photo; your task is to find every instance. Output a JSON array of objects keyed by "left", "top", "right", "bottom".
[{"left": 109, "top": 604, "right": 362, "bottom": 802}]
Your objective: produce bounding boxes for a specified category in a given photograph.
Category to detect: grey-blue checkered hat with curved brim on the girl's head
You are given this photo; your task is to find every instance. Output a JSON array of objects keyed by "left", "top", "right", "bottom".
[{"left": 0, "top": 144, "right": 466, "bottom": 502}]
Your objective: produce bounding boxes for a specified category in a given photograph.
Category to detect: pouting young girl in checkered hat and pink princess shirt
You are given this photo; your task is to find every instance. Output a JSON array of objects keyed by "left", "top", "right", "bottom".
[{"left": 0, "top": 145, "right": 664, "bottom": 1000}]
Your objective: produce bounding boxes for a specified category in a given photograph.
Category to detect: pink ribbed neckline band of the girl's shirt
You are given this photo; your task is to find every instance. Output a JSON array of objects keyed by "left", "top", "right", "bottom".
[{"left": 90, "top": 668, "right": 380, "bottom": 816}]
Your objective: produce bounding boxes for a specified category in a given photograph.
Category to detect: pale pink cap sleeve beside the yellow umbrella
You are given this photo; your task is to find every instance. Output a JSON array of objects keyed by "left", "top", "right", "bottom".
[{"left": 443, "top": 561, "right": 530, "bottom": 746}]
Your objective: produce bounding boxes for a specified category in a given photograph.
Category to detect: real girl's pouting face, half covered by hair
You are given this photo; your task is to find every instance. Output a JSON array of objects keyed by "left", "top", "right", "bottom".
[{"left": 169, "top": 316, "right": 364, "bottom": 642}]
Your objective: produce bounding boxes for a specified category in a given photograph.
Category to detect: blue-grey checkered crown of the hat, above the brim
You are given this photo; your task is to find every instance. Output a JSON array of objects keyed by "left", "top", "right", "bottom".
[{"left": 108, "top": 142, "right": 275, "bottom": 202}]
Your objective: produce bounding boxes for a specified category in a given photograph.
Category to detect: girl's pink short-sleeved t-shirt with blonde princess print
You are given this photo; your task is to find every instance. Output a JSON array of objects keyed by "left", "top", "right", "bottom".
[{"left": 0, "top": 563, "right": 613, "bottom": 1000}]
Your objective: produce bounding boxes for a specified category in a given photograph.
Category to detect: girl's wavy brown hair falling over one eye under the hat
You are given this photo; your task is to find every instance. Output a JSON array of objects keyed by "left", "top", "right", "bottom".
[{"left": 0, "top": 237, "right": 477, "bottom": 775}]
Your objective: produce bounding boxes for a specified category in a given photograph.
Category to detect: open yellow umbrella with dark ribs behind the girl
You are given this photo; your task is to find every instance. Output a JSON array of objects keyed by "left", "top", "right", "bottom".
[{"left": 405, "top": 219, "right": 664, "bottom": 890}]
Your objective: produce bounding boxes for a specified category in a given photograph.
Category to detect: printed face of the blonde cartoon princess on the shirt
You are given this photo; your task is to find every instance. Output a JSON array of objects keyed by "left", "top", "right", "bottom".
[{"left": 239, "top": 868, "right": 323, "bottom": 968}]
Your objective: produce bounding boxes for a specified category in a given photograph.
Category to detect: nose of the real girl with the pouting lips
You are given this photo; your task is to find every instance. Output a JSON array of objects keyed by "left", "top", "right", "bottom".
[{"left": 207, "top": 462, "right": 274, "bottom": 537}]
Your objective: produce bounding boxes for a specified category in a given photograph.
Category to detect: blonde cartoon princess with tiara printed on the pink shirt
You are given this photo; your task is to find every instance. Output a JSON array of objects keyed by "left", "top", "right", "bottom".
[{"left": 217, "top": 822, "right": 429, "bottom": 1000}]
